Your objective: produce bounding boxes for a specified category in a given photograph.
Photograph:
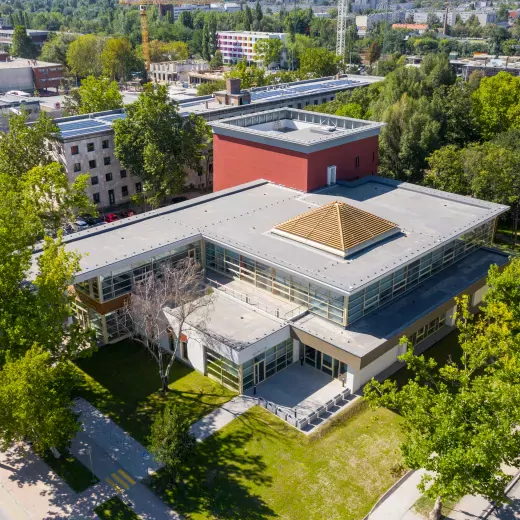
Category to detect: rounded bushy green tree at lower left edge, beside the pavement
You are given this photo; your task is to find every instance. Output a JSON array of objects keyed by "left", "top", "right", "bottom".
[{"left": 0, "top": 347, "right": 80, "bottom": 454}]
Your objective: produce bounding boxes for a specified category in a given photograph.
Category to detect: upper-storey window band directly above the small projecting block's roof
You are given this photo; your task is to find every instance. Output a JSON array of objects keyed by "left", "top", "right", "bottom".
[{"left": 206, "top": 242, "right": 345, "bottom": 325}]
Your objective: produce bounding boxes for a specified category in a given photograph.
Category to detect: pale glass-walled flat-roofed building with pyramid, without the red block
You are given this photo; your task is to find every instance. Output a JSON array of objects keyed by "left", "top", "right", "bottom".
[{"left": 36, "top": 171, "right": 508, "bottom": 402}]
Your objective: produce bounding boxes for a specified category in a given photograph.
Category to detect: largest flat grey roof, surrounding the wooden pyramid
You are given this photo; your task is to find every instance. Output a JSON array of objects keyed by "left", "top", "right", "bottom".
[{"left": 34, "top": 176, "right": 508, "bottom": 294}]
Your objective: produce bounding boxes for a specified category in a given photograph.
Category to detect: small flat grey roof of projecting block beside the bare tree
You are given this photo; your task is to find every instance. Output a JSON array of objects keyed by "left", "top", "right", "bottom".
[{"left": 166, "top": 290, "right": 287, "bottom": 352}]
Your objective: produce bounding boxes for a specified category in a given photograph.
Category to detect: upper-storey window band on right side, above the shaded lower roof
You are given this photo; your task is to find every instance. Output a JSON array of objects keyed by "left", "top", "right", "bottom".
[{"left": 347, "top": 221, "right": 495, "bottom": 324}]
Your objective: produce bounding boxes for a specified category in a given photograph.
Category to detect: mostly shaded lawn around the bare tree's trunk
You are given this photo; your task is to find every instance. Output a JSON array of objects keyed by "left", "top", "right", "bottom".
[{"left": 76, "top": 341, "right": 235, "bottom": 444}]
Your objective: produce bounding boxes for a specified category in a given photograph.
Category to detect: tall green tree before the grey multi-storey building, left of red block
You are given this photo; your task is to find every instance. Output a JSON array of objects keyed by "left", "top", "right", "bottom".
[{"left": 114, "top": 84, "right": 208, "bottom": 203}]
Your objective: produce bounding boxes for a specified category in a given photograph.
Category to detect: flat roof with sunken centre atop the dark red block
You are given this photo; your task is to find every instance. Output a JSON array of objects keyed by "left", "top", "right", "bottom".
[{"left": 210, "top": 108, "right": 386, "bottom": 153}]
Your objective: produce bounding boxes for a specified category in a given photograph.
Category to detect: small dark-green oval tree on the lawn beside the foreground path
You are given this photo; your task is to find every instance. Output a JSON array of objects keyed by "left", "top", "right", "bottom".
[{"left": 150, "top": 402, "right": 197, "bottom": 483}]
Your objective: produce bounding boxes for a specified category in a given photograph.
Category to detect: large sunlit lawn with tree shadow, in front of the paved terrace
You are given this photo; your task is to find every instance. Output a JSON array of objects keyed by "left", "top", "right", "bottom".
[{"left": 151, "top": 402, "right": 402, "bottom": 520}]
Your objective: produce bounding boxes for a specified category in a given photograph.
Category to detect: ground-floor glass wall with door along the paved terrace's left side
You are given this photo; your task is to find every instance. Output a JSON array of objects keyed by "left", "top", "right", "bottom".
[{"left": 242, "top": 338, "right": 293, "bottom": 391}]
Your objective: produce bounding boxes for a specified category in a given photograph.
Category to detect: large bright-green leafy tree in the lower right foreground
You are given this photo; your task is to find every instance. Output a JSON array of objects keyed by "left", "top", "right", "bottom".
[{"left": 364, "top": 259, "right": 520, "bottom": 519}]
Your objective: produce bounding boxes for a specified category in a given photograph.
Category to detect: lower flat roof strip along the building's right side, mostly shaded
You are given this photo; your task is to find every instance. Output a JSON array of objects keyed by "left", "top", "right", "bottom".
[{"left": 291, "top": 249, "right": 508, "bottom": 358}]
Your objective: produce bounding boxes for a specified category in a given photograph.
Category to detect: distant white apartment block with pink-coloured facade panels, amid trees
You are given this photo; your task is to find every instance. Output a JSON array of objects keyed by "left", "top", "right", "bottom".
[{"left": 217, "top": 31, "right": 287, "bottom": 65}]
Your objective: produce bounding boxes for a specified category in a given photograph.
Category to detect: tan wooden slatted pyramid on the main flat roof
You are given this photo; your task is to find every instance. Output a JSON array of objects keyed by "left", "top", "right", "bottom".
[{"left": 272, "top": 201, "right": 401, "bottom": 258}]
